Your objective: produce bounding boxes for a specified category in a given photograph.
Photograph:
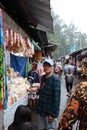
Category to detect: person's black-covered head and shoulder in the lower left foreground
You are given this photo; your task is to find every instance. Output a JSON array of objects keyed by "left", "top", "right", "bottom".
[{"left": 8, "top": 105, "right": 32, "bottom": 130}]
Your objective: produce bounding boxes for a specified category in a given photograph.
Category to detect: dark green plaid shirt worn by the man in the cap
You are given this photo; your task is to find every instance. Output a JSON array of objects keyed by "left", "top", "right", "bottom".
[{"left": 37, "top": 75, "right": 61, "bottom": 118}]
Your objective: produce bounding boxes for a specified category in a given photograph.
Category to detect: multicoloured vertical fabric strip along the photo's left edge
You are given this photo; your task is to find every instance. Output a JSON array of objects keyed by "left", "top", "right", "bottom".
[{"left": 0, "top": 9, "right": 4, "bottom": 109}]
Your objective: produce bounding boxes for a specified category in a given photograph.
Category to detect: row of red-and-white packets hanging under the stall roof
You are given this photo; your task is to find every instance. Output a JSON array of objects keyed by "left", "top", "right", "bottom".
[{"left": 5, "top": 29, "right": 34, "bottom": 57}]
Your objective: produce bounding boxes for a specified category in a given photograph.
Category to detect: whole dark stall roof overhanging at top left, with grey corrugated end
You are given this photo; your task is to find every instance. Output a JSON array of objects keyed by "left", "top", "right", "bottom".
[{"left": 0, "top": 0, "right": 53, "bottom": 42}]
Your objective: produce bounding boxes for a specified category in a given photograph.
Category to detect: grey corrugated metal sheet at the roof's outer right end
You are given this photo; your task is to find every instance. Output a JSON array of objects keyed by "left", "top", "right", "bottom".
[{"left": 25, "top": 0, "right": 53, "bottom": 32}]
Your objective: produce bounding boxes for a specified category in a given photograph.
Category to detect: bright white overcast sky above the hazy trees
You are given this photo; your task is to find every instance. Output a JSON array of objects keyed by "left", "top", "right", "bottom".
[{"left": 51, "top": 0, "right": 87, "bottom": 33}]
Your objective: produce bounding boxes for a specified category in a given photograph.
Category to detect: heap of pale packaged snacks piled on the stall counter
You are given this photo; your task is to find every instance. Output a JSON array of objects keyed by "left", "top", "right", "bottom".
[{"left": 7, "top": 66, "right": 31, "bottom": 106}]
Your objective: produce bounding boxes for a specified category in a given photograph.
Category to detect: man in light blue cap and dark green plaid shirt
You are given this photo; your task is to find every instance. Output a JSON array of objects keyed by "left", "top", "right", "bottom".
[{"left": 37, "top": 59, "right": 61, "bottom": 130}]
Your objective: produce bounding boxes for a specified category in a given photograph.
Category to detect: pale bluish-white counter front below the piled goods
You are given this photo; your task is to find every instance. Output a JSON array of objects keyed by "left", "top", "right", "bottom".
[{"left": 3, "top": 94, "right": 28, "bottom": 130}]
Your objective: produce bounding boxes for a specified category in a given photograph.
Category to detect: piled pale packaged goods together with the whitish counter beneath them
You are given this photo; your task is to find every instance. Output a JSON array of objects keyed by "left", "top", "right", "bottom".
[{"left": 3, "top": 68, "right": 30, "bottom": 130}]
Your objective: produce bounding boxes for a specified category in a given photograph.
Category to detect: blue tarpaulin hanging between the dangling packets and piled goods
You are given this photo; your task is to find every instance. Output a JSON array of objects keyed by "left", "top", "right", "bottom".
[{"left": 10, "top": 53, "right": 27, "bottom": 77}]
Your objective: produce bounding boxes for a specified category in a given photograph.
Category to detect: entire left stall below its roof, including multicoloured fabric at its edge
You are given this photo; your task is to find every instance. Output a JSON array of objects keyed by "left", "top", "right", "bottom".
[{"left": 0, "top": 10, "right": 34, "bottom": 130}]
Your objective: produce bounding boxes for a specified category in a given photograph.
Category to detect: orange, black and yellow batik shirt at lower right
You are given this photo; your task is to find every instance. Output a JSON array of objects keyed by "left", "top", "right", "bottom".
[{"left": 58, "top": 82, "right": 87, "bottom": 130}]
